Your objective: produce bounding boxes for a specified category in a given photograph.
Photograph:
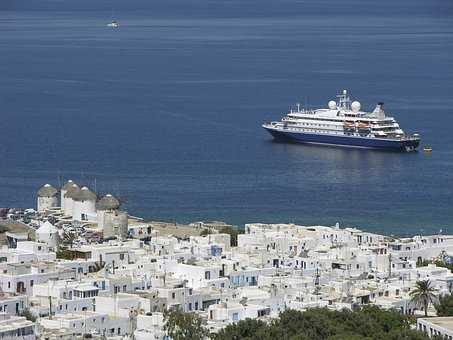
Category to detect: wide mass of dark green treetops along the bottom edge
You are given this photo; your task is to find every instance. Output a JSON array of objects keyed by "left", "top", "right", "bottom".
[{"left": 212, "top": 306, "right": 428, "bottom": 340}]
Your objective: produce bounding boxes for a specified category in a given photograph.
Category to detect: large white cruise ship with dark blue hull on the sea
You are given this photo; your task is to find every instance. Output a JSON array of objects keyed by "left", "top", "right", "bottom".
[{"left": 262, "top": 90, "right": 420, "bottom": 151}]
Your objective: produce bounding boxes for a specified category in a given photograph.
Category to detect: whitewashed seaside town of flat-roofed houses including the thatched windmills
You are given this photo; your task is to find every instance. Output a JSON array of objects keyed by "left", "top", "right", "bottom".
[{"left": 0, "top": 180, "right": 453, "bottom": 340}]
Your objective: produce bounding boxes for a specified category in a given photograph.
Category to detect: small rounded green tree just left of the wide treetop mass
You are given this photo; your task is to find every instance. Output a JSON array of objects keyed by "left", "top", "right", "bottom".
[{"left": 164, "top": 310, "right": 209, "bottom": 340}]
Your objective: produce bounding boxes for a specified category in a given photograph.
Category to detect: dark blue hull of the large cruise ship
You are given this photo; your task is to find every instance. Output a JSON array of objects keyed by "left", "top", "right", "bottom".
[{"left": 263, "top": 126, "right": 420, "bottom": 151}]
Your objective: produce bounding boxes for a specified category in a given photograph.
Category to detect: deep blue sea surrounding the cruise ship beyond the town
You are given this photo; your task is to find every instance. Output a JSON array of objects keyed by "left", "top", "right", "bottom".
[{"left": 0, "top": 0, "right": 453, "bottom": 234}]
